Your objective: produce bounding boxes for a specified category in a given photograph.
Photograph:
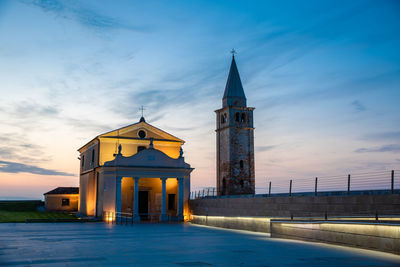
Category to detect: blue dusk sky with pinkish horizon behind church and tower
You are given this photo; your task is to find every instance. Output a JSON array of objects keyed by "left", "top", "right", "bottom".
[{"left": 0, "top": 0, "right": 400, "bottom": 198}]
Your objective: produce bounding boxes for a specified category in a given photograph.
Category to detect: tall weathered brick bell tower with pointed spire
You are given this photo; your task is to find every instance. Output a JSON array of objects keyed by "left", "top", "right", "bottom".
[{"left": 215, "top": 50, "right": 255, "bottom": 196}]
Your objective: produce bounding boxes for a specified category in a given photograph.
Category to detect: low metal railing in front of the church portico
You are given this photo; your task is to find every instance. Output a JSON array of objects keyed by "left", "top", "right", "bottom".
[{"left": 103, "top": 211, "right": 167, "bottom": 225}]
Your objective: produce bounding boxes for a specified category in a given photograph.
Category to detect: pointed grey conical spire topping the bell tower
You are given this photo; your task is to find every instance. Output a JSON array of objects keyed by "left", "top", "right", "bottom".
[{"left": 222, "top": 53, "right": 246, "bottom": 107}]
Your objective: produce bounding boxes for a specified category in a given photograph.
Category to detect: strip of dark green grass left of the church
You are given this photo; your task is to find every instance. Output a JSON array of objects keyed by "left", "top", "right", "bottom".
[{"left": 0, "top": 210, "right": 76, "bottom": 223}]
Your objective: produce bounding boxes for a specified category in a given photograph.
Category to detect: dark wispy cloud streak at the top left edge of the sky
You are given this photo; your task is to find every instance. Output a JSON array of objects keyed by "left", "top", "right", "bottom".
[{"left": 22, "top": 0, "right": 143, "bottom": 31}]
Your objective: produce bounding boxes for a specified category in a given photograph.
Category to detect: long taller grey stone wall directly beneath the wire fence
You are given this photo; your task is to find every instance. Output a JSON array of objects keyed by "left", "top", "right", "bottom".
[{"left": 190, "top": 194, "right": 400, "bottom": 218}]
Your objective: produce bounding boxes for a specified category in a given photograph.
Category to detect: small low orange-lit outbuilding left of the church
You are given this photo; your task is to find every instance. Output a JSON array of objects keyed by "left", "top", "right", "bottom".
[{"left": 44, "top": 187, "right": 79, "bottom": 211}]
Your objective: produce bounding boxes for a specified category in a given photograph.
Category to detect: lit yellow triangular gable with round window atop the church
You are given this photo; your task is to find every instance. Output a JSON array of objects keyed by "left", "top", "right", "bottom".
[{"left": 99, "top": 122, "right": 184, "bottom": 143}]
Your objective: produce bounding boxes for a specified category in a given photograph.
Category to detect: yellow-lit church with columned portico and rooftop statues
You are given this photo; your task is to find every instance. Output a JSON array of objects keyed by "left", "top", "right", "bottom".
[{"left": 78, "top": 117, "right": 193, "bottom": 221}]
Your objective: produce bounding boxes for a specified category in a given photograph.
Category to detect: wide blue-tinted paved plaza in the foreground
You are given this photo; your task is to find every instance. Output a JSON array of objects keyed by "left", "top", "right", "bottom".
[{"left": 0, "top": 223, "right": 400, "bottom": 266}]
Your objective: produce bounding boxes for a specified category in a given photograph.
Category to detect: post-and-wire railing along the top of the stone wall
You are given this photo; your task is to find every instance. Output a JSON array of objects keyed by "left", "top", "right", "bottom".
[{"left": 190, "top": 170, "right": 400, "bottom": 199}]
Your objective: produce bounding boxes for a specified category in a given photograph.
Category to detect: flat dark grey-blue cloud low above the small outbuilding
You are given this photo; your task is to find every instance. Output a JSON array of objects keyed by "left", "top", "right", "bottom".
[{"left": 0, "top": 160, "right": 75, "bottom": 176}]
